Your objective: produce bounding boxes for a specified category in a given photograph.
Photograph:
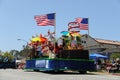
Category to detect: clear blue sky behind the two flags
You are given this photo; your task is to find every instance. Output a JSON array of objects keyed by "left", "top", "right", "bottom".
[{"left": 0, "top": 0, "right": 120, "bottom": 51}]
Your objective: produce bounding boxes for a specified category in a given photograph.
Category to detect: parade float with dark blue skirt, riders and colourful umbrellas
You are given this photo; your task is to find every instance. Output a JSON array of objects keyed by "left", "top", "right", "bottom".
[{"left": 25, "top": 14, "right": 95, "bottom": 73}]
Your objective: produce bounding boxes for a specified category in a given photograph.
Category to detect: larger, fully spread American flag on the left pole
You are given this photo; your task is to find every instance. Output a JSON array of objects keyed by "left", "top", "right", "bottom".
[{"left": 34, "top": 13, "right": 55, "bottom": 26}]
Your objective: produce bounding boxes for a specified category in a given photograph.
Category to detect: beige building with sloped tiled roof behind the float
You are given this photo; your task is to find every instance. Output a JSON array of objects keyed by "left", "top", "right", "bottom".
[{"left": 81, "top": 34, "right": 120, "bottom": 53}]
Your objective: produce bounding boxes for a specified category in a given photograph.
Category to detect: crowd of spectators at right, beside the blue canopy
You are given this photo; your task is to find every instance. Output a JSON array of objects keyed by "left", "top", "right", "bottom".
[{"left": 96, "top": 58, "right": 120, "bottom": 73}]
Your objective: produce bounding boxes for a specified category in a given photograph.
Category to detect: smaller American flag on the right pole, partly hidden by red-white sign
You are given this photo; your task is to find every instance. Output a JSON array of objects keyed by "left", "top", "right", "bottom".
[{"left": 75, "top": 18, "right": 88, "bottom": 30}]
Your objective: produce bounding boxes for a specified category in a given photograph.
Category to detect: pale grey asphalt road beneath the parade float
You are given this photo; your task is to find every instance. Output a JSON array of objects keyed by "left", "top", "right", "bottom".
[{"left": 0, "top": 69, "right": 120, "bottom": 80}]
